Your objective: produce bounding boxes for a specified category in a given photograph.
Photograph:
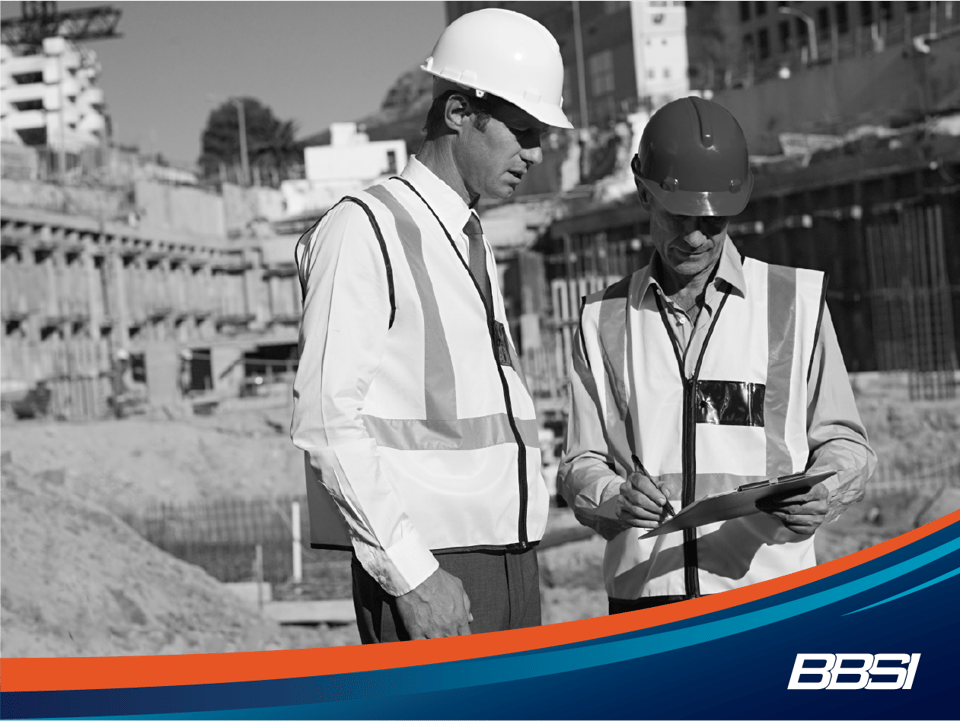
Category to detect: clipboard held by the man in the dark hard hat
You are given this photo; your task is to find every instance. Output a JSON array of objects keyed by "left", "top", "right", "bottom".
[{"left": 640, "top": 471, "right": 836, "bottom": 538}]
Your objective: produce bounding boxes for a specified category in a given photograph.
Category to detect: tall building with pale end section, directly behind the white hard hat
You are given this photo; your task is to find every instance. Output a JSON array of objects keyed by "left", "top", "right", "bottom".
[{"left": 445, "top": 0, "right": 689, "bottom": 127}]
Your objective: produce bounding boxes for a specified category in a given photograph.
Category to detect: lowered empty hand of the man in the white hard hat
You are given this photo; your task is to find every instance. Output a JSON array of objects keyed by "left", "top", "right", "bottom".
[{"left": 397, "top": 568, "right": 473, "bottom": 639}]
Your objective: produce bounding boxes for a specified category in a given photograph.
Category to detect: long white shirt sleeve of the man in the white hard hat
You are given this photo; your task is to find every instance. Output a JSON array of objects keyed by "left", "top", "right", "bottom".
[{"left": 290, "top": 202, "right": 437, "bottom": 596}]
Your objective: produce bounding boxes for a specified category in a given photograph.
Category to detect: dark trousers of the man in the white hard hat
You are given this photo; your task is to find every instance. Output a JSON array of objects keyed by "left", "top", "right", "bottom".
[{"left": 351, "top": 548, "right": 540, "bottom": 643}]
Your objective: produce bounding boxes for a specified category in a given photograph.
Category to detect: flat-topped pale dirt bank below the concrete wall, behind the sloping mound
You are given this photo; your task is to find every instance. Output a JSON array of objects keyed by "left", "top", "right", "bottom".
[{"left": 0, "top": 413, "right": 304, "bottom": 513}]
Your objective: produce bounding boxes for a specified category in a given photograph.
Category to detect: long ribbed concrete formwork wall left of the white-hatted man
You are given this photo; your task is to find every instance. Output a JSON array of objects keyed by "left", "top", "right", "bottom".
[{"left": 0, "top": 206, "right": 300, "bottom": 418}]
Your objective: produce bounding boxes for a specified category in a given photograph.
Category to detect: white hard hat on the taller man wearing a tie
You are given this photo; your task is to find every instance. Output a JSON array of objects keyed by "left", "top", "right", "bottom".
[{"left": 420, "top": 8, "right": 573, "bottom": 128}]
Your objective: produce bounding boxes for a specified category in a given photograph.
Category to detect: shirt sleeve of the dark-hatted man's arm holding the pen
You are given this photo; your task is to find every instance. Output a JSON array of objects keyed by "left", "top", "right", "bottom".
[{"left": 557, "top": 312, "right": 623, "bottom": 540}]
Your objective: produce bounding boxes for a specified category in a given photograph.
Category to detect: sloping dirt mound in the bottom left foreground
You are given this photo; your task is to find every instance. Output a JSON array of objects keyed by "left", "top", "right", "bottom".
[{"left": 0, "top": 467, "right": 359, "bottom": 658}]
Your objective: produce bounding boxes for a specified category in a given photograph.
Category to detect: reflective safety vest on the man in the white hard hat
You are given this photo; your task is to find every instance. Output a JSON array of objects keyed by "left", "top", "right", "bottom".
[{"left": 301, "top": 178, "right": 549, "bottom": 552}]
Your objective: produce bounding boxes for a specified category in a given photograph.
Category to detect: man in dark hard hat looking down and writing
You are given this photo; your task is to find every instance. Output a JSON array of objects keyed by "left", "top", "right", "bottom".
[{"left": 558, "top": 97, "right": 876, "bottom": 613}]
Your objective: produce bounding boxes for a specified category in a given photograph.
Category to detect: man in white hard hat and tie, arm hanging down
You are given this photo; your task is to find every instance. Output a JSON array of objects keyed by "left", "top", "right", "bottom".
[{"left": 291, "top": 9, "right": 571, "bottom": 643}]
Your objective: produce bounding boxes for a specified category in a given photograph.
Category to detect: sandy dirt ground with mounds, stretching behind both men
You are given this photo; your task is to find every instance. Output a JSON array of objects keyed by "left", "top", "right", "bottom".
[{"left": 0, "top": 377, "right": 960, "bottom": 657}]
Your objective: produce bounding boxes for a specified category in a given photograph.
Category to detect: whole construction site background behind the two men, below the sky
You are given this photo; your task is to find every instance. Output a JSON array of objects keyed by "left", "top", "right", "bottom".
[{"left": 0, "top": 1, "right": 960, "bottom": 656}]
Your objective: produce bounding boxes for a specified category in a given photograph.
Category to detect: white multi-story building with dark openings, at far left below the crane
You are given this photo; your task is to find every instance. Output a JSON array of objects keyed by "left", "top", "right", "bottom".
[{"left": 0, "top": 37, "right": 107, "bottom": 153}]
